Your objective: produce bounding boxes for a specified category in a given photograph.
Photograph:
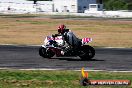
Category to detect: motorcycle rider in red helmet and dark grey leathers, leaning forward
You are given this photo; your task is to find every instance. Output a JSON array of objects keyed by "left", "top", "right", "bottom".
[{"left": 53, "top": 24, "right": 81, "bottom": 54}]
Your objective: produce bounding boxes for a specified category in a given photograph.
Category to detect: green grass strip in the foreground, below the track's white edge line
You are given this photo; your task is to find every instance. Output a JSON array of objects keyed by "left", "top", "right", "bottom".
[{"left": 0, "top": 70, "right": 132, "bottom": 88}]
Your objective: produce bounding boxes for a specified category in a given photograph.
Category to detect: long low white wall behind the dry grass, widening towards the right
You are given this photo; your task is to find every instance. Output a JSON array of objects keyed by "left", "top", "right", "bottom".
[{"left": 35, "top": 11, "right": 132, "bottom": 18}]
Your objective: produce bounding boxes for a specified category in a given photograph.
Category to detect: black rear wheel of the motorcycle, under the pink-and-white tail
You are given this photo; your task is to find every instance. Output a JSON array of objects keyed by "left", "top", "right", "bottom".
[{"left": 79, "top": 46, "right": 95, "bottom": 60}]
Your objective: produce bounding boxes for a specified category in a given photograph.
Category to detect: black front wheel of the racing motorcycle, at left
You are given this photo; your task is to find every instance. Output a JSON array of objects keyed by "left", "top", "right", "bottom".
[{"left": 39, "top": 47, "right": 55, "bottom": 58}]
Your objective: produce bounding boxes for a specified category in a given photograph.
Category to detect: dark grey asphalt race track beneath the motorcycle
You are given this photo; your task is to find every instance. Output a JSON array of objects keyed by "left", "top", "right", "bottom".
[{"left": 0, "top": 45, "right": 132, "bottom": 71}]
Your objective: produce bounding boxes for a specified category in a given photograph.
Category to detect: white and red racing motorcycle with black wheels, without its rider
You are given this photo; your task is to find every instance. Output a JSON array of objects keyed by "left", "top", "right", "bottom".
[{"left": 39, "top": 36, "right": 95, "bottom": 60}]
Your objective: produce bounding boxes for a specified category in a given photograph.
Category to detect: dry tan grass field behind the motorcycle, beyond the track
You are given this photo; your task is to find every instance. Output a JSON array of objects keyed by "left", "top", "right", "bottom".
[{"left": 0, "top": 14, "right": 132, "bottom": 48}]
